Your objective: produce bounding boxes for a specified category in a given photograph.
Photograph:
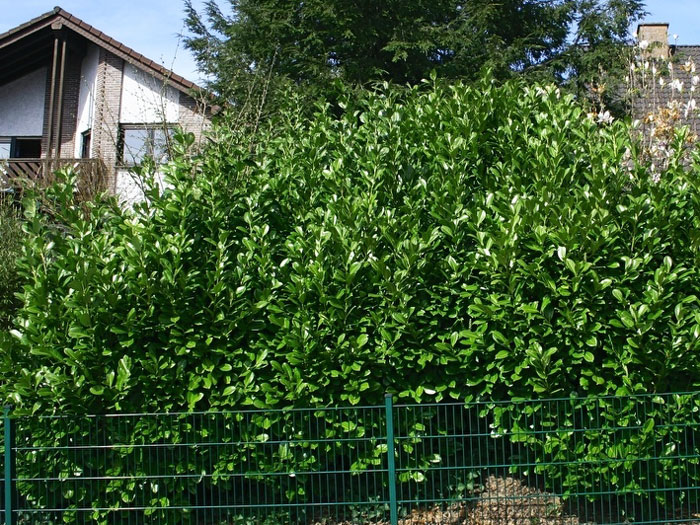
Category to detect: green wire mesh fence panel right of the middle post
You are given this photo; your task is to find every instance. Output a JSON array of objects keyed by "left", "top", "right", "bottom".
[{"left": 395, "top": 394, "right": 700, "bottom": 525}]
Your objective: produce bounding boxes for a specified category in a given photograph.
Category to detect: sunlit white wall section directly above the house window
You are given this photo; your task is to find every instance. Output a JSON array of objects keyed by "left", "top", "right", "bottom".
[{"left": 119, "top": 63, "right": 180, "bottom": 124}]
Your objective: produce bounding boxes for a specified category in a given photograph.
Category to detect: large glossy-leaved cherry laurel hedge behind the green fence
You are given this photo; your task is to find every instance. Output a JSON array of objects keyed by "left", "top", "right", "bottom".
[{"left": 0, "top": 80, "right": 700, "bottom": 520}]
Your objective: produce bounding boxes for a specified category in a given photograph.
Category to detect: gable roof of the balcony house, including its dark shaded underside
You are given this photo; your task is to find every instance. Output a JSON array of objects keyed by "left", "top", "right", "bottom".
[{"left": 0, "top": 7, "right": 201, "bottom": 92}]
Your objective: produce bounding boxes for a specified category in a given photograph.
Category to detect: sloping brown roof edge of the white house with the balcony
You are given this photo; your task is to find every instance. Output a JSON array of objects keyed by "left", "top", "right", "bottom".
[{"left": 0, "top": 7, "right": 201, "bottom": 92}]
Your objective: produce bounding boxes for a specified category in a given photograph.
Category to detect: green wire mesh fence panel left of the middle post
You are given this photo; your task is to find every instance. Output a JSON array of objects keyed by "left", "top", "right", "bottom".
[{"left": 16, "top": 408, "right": 386, "bottom": 524}]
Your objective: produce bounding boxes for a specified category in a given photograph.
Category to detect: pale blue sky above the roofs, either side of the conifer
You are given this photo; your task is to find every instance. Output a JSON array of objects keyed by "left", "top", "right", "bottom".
[{"left": 0, "top": 0, "right": 700, "bottom": 82}]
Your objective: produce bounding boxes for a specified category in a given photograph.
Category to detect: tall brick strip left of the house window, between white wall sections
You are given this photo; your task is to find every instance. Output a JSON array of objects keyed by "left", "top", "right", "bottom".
[{"left": 92, "top": 49, "right": 124, "bottom": 191}]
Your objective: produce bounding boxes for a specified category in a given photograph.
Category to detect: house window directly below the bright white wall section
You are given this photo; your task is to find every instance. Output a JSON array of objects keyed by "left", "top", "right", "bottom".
[{"left": 120, "top": 124, "right": 174, "bottom": 166}]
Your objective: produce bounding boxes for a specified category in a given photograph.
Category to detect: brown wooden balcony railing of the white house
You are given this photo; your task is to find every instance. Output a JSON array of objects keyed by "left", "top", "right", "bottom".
[{"left": 0, "top": 159, "right": 107, "bottom": 200}]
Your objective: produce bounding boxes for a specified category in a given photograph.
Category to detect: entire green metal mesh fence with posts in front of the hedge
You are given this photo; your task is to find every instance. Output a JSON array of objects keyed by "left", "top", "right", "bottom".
[{"left": 0, "top": 393, "right": 700, "bottom": 525}]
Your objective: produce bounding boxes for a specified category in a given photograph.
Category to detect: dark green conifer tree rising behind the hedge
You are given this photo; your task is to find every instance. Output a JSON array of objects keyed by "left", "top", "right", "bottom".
[{"left": 185, "top": 0, "right": 644, "bottom": 104}]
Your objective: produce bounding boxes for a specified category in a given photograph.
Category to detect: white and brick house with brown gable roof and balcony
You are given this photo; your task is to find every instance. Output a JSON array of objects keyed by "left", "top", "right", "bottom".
[{"left": 0, "top": 7, "right": 208, "bottom": 201}]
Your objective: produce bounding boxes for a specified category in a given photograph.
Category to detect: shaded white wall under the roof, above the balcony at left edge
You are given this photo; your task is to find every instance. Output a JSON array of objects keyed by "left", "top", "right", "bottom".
[{"left": 0, "top": 68, "right": 47, "bottom": 137}]
